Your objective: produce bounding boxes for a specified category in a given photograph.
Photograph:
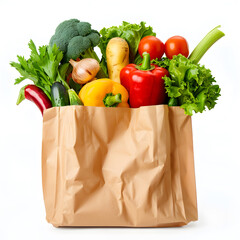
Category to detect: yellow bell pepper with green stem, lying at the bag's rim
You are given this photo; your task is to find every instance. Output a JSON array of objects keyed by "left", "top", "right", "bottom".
[{"left": 79, "top": 78, "right": 129, "bottom": 107}]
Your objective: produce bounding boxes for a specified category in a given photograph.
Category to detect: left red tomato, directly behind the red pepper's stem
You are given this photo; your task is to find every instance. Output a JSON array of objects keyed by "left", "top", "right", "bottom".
[{"left": 138, "top": 36, "right": 164, "bottom": 60}]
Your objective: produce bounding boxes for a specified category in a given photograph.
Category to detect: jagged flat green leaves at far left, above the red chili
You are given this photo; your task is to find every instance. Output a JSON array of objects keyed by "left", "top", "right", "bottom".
[{"left": 10, "top": 40, "right": 69, "bottom": 104}]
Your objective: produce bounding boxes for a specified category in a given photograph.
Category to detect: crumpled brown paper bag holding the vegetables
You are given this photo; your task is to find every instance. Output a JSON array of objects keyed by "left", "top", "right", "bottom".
[{"left": 42, "top": 105, "right": 197, "bottom": 227}]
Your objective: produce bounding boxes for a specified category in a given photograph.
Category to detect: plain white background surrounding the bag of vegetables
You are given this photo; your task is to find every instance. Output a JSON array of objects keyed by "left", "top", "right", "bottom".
[{"left": 0, "top": 0, "right": 240, "bottom": 240}]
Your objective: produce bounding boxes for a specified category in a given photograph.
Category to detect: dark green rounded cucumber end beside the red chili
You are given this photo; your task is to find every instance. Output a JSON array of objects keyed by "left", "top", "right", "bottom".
[{"left": 51, "top": 82, "right": 70, "bottom": 107}]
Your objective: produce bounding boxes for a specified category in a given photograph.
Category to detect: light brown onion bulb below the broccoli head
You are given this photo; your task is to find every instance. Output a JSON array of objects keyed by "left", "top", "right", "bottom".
[{"left": 69, "top": 58, "right": 100, "bottom": 84}]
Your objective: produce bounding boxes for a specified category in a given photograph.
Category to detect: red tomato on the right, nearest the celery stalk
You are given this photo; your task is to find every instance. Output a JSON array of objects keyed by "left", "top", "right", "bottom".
[{"left": 165, "top": 36, "right": 189, "bottom": 59}]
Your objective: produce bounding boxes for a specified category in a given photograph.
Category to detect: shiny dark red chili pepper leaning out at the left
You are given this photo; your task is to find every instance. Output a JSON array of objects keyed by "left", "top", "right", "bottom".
[{"left": 24, "top": 85, "right": 52, "bottom": 114}]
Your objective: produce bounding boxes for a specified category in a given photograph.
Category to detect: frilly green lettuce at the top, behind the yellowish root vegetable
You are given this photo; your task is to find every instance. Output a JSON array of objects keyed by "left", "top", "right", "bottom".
[{"left": 98, "top": 21, "right": 156, "bottom": 74}]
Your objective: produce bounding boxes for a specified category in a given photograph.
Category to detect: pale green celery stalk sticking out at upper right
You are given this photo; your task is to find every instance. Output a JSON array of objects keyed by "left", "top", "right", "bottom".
[{"left": 189, "top": 25, "right": 225, "bottom": 64}]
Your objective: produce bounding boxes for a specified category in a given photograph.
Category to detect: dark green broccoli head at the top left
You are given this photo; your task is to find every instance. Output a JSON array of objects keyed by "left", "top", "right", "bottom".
[{"left": 49, "top": 19, "right": 100, "bottom": 62}]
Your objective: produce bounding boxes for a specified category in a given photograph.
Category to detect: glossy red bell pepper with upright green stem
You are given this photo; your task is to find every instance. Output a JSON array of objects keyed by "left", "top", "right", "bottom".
[{"left": 120, "top": 52, "right": 169, "bottom": 108}]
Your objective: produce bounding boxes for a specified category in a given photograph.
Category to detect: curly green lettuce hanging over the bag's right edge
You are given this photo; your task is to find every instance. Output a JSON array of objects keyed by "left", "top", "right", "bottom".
[{"left": 154, "top": 54, "right": 220, "bottom": 116}]
